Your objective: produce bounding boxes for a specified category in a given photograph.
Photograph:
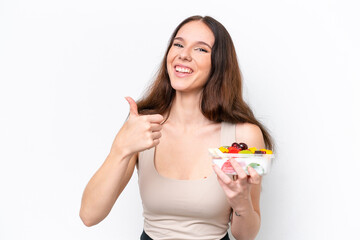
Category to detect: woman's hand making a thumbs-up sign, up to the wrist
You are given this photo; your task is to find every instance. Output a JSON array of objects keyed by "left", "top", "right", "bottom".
[{"left": 111, "top": 97, "right": 164, "bottom": 156}]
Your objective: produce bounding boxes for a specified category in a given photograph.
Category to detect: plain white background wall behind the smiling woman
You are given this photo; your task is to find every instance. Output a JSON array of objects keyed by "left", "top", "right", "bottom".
[{"left": 0, "top": 0, "right": 360, "bottom": 240}]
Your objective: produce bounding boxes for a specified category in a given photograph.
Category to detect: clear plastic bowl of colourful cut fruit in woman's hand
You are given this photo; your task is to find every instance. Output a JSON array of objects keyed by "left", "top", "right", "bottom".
[{"left": 209, "top": 142, "right": 274, "bottom": 175}]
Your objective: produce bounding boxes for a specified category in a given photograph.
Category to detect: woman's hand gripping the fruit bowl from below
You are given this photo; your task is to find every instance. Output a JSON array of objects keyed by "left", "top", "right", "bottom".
[{"left": 213, "top": 159, "right": 261, "bottom": 209}]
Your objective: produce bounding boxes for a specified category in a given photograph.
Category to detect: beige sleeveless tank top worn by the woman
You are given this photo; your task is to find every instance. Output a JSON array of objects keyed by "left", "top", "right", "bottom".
[{"left": 138, "top": 123, "right": 236, "bottom": 240}]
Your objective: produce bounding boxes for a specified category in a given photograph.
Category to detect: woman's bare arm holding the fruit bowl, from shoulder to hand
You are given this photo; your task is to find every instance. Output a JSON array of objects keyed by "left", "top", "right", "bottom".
[{"left": 213, "top": 123, "right": 265, "bottom": 240}]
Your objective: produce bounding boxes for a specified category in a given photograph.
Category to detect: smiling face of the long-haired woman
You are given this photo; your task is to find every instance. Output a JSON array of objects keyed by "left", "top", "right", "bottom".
[{"left": 167, "top": 21, "right": 215, "bottom": 92}]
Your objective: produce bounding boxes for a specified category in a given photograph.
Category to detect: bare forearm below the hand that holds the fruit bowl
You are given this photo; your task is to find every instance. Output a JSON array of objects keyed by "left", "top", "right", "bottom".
[{"left": 231, "top": 200, "right": 260, "bottom": 240}]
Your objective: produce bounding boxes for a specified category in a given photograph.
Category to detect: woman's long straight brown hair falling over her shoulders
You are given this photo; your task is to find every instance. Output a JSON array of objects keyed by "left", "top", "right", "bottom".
[{"left": 137, "top": 16, "right": 273, "bottom": 149}]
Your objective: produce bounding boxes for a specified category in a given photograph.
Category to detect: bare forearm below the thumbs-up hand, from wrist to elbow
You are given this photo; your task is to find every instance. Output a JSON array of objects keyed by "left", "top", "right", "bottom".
[{"left": 80, "top": 154, "right": 131, "bottom": 226}]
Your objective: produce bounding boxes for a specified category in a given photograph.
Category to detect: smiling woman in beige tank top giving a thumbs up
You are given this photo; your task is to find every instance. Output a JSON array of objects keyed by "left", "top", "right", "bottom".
[{"left": 80, "top": 16, "right": 272, "bottom": 240}]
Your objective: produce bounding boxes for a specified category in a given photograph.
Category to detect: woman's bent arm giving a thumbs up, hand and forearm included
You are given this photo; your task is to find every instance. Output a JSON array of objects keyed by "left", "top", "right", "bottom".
[{"left": 80, "top": 98, "right": 163, "bottom": 226}]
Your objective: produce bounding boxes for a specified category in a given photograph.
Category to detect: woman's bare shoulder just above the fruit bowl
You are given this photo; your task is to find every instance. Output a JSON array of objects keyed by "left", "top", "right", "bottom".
[{"left": 236, "top": 123, "right": 265, "bottom": 149}]
